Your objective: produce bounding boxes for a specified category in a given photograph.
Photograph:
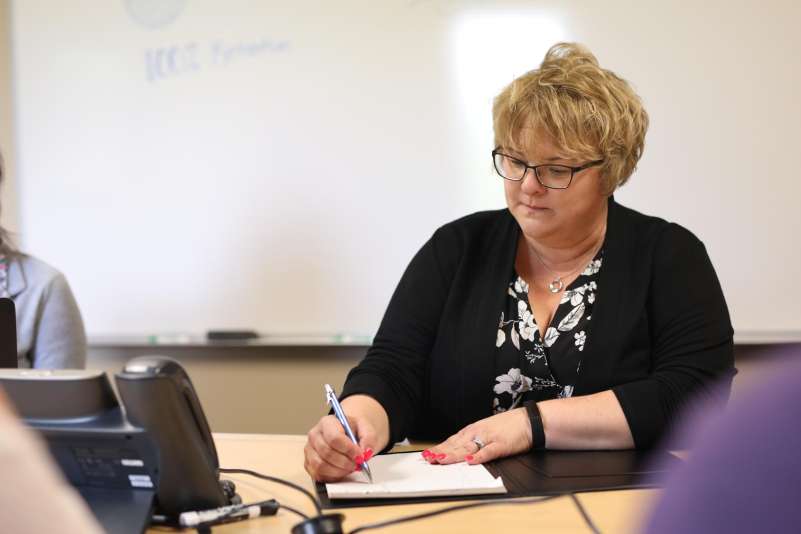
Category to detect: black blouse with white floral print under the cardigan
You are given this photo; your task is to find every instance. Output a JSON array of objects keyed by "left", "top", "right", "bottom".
[{"left": 492, "top": 249, "right": 603, "bottom": 413}]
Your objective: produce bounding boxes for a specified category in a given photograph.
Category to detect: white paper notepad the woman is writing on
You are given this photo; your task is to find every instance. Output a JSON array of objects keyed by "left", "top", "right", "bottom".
[{"left": 325, "top": 452, "right": 506, "bottom": 499}]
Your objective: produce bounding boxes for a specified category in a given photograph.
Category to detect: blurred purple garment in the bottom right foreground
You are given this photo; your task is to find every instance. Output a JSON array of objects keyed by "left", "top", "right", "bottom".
[{"left": 645, "top": 356, "right": 801, "bottom": 534}]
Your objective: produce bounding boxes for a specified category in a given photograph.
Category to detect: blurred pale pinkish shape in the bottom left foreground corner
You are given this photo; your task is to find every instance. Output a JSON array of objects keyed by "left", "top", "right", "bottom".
[{"left": 0, "top": 389, "right": 102, "bottom": 534}]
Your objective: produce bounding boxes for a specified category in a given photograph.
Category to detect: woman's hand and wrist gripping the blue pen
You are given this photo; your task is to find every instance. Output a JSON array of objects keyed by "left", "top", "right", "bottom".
[{"left": 304, "top": 395, "right": 389, "bottom": 482}]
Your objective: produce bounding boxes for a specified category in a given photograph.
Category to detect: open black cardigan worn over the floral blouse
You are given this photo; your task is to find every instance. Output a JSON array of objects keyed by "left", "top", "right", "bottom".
[{"left": 342, "top": 198, "right": 734, "bottom": 448}]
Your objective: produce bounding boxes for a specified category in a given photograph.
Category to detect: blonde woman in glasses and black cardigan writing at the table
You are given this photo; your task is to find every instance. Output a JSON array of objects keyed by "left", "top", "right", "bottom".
[{"left": 305, "top": 43, "right": 733, "bottom": 481}]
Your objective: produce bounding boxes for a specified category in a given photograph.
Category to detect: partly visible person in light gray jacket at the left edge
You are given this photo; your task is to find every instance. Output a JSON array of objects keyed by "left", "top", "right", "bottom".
[{"left": 0, "top": 149, "right": 86, "bottom": 369}]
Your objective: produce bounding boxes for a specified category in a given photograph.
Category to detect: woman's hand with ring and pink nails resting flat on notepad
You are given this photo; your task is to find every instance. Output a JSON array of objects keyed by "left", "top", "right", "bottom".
[{"left": 423, "top": 408, "right": 531, "bottom": 464}]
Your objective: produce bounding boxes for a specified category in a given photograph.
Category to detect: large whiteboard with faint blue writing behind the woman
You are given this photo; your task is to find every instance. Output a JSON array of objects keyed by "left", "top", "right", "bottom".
[{"left": 12, "top": 0, "right": 801, "bottom": 335}]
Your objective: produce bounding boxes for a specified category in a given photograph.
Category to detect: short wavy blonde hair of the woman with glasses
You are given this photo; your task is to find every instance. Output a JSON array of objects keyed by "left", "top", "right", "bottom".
[{"left": 492, "top": 43, "right": 648, "bottom": 194}]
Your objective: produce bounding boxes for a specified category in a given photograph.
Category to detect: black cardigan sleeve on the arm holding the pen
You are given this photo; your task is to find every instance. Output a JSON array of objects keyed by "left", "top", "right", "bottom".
[{"left": 342, "top": 228, "right": 459, "bottom": 446}]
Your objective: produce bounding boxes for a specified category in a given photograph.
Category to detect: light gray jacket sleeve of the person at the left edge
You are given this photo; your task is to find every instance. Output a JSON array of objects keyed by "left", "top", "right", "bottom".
[{"left": 30, "top": 274, "right": 86, "bottom": 369}]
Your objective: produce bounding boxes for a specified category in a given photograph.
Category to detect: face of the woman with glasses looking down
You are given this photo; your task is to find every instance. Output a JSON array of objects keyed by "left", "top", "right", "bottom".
[{"left": 503, "top": 130, "right": 607, "bottom": 246}]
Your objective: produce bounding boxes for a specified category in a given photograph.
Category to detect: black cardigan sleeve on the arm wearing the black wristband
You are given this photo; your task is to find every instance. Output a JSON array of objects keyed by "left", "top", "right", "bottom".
[{"left": 613, "top": 224, "right": 734, "bottom": 448}]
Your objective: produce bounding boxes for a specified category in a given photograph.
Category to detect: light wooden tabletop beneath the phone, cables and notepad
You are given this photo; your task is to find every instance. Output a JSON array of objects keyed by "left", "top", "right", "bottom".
[{"left": 149, "top": 434, "right": 659, "bottom": 534}]
